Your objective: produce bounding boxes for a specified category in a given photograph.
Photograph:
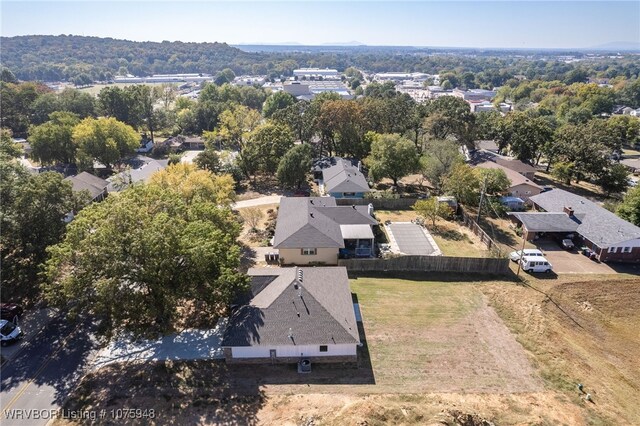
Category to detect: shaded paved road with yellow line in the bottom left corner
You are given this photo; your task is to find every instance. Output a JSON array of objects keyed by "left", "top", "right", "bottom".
[{"left": 0, "top": 317, "right": 96, "bottom": 426}]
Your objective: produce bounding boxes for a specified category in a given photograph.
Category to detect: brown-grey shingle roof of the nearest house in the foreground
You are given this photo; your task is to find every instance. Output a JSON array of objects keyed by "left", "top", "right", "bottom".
[{"left": 222, "top": 267, "right": 360, "bottom": 347}]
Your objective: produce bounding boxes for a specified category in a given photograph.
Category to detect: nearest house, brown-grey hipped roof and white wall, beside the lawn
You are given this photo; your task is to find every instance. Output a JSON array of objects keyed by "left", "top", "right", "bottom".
[{"left": 221, "top": 267, "right": 360, "bottom": 363}]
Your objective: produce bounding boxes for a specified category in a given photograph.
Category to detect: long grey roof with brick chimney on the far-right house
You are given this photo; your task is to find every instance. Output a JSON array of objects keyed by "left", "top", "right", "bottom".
[{"left": 529, "top": 189, "right": 640, "bottom": 248}]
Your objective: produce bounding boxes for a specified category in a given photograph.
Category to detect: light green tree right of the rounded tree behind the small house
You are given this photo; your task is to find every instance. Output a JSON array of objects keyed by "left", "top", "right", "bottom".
[{"left": 420, "top": 139, "right": 464, "bottom": 191}]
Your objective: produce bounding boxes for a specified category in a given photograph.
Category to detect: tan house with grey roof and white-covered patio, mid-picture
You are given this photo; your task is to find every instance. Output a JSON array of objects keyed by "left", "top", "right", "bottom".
[{"left": 273, "top": 197, "right": 377, "bottom": 265}]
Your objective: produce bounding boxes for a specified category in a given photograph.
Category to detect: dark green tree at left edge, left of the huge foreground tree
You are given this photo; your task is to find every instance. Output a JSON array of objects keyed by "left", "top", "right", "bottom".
[{"left": 0, "top": 161, "right": 80, "bottom": 302}]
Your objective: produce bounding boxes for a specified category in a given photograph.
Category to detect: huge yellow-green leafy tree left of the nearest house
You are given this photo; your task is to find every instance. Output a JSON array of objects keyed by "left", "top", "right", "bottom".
[{"left": 44, "top": 165, "right": 247, "bottom": 337}]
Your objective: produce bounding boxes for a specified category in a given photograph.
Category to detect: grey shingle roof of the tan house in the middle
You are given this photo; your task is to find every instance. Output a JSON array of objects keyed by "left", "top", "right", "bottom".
[{"left": 273, "top": 197, "right": 377, "bottom": 248}]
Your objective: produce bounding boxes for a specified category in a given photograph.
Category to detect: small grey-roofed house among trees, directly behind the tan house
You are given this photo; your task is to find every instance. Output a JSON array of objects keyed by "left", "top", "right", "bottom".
[{"left": 314, "top": 157, "right": 371, "bottom": 198}]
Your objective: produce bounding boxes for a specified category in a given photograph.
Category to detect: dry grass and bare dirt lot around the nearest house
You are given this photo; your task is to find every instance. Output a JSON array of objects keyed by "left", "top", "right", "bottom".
[{"left": 58, "top": 275, "right": 640, "bottom": 426}]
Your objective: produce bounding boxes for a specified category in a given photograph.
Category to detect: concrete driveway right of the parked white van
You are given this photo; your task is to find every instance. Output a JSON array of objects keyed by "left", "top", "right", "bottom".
[{"left": 535, "top": 240, "right": 616, "bottom": 274}]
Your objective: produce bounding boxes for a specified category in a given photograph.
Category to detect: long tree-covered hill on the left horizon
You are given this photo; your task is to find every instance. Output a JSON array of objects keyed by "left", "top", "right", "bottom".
[{"left": 0, "top": 35, "right": 260, "bottom": 81}]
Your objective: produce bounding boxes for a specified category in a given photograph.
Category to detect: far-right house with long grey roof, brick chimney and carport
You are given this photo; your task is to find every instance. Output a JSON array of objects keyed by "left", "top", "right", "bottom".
[{"left": 530, "top": 189, "right": 640, "bottom": 262}]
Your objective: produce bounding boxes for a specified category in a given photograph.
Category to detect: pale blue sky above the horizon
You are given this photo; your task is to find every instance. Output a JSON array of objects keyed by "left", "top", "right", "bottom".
[{"left": 0, "top": 0, "right": 640, "bottom": 48}]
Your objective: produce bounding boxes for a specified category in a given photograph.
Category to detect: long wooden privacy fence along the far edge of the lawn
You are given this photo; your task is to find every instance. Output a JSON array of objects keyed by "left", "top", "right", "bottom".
[{"left": 338, "top": 256, "right": 509, "bottom": 274}]
